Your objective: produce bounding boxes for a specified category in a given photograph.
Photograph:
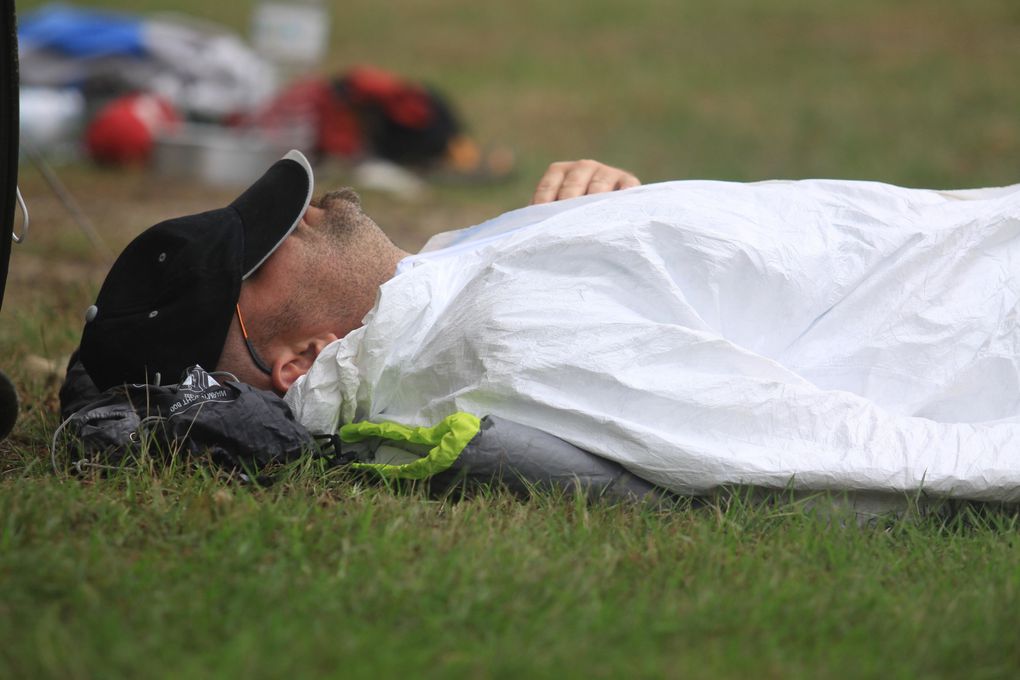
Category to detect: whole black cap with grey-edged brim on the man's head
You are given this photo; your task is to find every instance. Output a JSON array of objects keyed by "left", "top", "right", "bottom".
[{"left": 80, "top": 151, "right": 313, "bottom": 389}]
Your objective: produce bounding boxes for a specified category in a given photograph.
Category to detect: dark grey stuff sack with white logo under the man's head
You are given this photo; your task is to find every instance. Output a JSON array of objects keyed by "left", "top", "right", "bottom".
[{"left": 54, "top": 357, "right": 339, "bottom": 470}]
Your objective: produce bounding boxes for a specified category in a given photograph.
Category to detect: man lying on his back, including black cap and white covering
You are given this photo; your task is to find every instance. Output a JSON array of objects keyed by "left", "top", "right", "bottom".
[{"left": 82, "top": 154, "right": 1020, "bottom": 501}]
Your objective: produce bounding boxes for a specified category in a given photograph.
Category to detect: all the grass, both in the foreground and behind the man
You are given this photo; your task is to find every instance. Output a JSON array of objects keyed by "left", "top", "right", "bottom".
[{"left": 0, "top": 0, "right": 1020, "bottom": 678}]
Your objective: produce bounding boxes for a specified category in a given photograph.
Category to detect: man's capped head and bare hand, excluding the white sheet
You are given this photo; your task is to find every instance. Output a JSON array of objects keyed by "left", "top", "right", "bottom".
[{"left": 81, "top": 151, "right": 640, "bottom": 395}]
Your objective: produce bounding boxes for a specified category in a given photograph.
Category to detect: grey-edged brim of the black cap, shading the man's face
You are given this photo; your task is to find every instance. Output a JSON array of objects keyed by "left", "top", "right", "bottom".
[{"left": 231, "top": 149, "right": 315, "bottom": 280}]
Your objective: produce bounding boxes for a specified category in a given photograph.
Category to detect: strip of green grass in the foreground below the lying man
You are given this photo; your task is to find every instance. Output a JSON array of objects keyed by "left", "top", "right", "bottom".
[{"left": 0, "top": 460, "right": 1020, "bottom": 677}]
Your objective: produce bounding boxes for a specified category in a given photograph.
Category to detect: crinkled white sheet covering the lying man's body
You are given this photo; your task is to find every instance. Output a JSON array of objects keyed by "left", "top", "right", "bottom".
[{"left": 287, "top": 180, "right": 1020, "bottom": 501}]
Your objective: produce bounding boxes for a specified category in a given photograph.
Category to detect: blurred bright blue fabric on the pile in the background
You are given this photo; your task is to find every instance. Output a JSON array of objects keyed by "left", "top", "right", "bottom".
[{"left": 17, "top": 5, "right": 146, "bottom": 58}]
